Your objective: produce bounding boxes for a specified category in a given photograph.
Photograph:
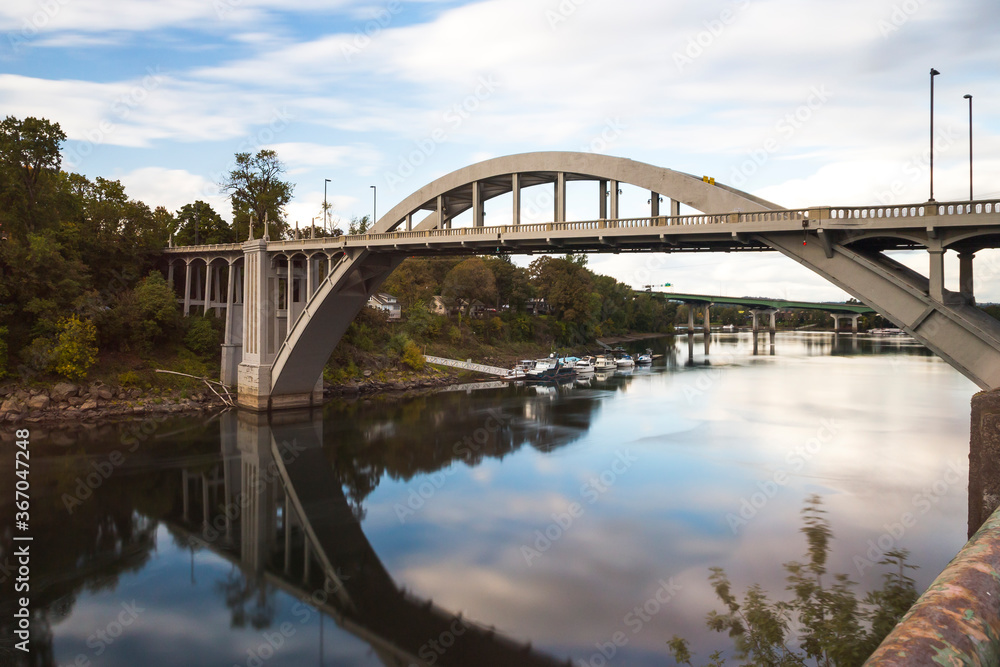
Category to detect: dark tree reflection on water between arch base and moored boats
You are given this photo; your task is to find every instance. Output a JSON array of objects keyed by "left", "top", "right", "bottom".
[{"left": 325, "top": 387, "right": 599, "bottom": 506}]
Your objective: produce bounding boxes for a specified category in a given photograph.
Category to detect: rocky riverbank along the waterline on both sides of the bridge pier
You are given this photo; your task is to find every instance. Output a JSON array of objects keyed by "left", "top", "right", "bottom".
[{"left": 0, "top": 374, "right": 459, "bottom": 424}]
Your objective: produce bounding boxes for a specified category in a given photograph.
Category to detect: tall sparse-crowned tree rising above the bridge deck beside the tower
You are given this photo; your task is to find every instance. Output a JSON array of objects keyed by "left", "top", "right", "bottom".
[{"left": 220, "top": 148, "right": 293, "bottom": 241}]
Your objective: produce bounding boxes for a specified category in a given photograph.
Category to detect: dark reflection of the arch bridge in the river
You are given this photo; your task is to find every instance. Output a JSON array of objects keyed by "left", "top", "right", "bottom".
[{"left": 166, "top": 411, "right": 567, "bottom": 666}]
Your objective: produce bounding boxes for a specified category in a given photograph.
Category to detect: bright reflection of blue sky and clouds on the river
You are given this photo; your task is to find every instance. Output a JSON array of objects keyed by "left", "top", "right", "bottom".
[{"left": 369, "top": 338, "right": 972, "bottom": 659}]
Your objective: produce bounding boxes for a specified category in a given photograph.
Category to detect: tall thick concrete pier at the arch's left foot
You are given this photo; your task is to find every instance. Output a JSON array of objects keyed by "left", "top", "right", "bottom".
[{"left": 238, "top": 241, "right": 278, "bottom": 410}]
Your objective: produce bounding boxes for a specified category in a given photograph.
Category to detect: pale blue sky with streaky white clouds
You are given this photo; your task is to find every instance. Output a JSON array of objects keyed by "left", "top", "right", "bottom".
[{"left": 0, "top": 0, "right": 1000, "bottom": 300}]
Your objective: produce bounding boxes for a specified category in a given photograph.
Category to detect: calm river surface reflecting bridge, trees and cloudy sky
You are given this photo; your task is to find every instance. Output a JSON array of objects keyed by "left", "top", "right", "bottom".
[{"left": 0, "top": 333, "right": 976, "bottom": 666}]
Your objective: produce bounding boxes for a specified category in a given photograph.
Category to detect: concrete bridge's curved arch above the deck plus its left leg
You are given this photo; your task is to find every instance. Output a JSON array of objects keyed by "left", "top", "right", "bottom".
[{"left": 258, "top": 152, "right": 778, "bottom": 408}]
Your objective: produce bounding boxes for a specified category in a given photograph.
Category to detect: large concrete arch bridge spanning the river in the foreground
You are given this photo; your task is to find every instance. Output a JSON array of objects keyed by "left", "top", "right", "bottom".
[{"left": 165, "top": 152, "right": 1000, "bottom": 410}]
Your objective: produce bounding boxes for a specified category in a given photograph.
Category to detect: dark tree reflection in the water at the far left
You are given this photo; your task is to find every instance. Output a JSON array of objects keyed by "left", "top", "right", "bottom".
[{"left": 0, "top": 426, "right": 218, "bottom": 666}]
